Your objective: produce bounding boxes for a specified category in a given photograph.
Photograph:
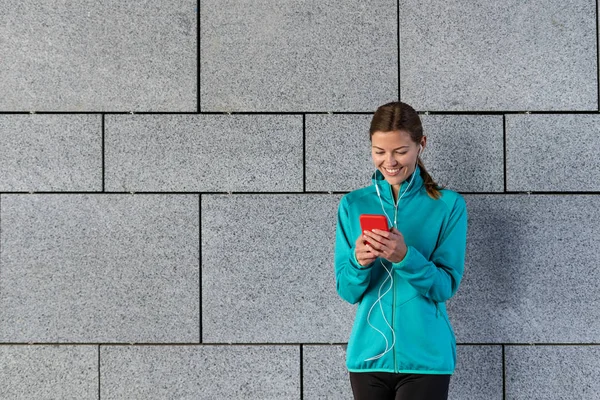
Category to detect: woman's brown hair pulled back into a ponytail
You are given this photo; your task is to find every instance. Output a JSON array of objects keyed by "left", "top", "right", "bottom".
[{"left": 369, "top": 101, "right": 443, "bottom": 200}]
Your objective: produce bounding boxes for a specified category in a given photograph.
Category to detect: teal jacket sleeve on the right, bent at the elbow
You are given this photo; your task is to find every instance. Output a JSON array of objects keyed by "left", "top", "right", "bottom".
[{"left": 393, "top": 195, "right": 467, "bottom": 303}]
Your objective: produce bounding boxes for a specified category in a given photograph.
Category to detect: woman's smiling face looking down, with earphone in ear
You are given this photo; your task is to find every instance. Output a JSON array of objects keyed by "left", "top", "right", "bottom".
[{"left": 371, "top": 131, "right": 427, "bottom": 185}]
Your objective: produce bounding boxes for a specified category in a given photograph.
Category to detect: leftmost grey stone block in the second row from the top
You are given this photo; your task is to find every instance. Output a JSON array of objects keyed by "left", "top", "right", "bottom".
[{"left": 0, "top": 114, "right": 102, "bottom": 192}]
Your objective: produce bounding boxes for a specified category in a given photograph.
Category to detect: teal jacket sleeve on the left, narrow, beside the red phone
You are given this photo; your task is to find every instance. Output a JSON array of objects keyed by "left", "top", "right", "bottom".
[{"left": 334, "top": 196, "right": 373, "bottom": 304}]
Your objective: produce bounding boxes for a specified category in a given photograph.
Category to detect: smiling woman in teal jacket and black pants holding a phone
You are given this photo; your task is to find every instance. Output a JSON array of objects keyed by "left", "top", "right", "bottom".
[{"left": 335, "top": 102, "right": 467, "bottom": 400}]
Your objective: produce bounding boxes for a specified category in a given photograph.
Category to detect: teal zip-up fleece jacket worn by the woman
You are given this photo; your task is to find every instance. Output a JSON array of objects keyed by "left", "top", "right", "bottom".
[{"left": 335, "top": 167, "right": 467, "bottom": 374}]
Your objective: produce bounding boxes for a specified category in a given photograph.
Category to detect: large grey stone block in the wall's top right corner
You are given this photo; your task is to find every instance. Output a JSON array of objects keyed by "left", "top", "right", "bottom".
[{"left": 399, "top": 0, "right": 598, "bottom": 111}]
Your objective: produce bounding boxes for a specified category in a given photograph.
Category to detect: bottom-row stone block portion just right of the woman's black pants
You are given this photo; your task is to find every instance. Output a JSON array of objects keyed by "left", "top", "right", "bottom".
[{"left": 448, "top": 345, "right": 503, "bottom": 400}]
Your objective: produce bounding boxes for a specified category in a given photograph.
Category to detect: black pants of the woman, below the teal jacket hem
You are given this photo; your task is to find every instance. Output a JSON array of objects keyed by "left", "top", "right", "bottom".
[{"left": 350, "top": 372, "right": 451, "bottom": 400}]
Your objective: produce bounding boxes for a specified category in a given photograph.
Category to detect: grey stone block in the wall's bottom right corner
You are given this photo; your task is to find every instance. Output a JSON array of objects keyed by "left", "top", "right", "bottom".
[{"left": 506, "top": 346, "right": 600, "bottom": 400}]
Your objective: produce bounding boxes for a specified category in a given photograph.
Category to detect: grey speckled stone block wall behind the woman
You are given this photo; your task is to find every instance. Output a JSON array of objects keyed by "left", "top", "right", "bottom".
[{"left": 0, "top": 0, "right": 600, "bottom": 400}]
